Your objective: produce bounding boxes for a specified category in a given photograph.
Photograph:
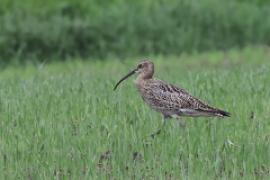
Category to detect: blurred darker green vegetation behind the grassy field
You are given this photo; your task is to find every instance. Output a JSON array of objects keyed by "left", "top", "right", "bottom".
[{"left": 0, "top": 0, "right": 270, "bottom": 64}]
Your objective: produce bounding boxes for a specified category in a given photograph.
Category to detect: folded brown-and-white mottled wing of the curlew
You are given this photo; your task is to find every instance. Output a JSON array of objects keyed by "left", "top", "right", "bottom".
[{"left": 143, "top": 79, "right": 214, "bottom": 113}]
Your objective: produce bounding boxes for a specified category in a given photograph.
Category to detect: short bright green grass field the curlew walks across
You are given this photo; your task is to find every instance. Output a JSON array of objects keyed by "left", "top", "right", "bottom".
[{"left": 0, "top": 47, "right": 270, "bottom": 179}]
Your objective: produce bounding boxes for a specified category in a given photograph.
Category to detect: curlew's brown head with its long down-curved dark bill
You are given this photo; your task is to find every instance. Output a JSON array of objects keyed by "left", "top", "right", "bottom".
[{"left": 114, "top": 60, "right": 154, "bottom": 90}]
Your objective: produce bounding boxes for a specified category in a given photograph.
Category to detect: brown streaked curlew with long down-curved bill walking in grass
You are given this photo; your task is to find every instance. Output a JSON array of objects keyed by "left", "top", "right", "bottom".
[{"left": 114, "top": 60, "right": 230, "bottom": 137}]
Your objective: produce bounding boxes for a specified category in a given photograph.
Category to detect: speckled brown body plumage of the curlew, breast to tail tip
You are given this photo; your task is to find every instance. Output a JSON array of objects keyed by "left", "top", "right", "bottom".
[{"left": 136, "top": 79, "right": 228, "bottom": 117}]
